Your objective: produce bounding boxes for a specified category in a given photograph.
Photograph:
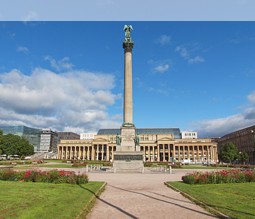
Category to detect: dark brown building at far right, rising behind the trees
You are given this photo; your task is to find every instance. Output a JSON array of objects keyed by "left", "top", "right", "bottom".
[{"left": 218, "top": 125, "right": 255, "bottom": 164}]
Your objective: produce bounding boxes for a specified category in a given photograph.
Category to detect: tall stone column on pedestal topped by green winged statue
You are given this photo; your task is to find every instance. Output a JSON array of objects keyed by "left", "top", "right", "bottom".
[{"left": 113, "top": 25, "right": 145, "bottom": 172}]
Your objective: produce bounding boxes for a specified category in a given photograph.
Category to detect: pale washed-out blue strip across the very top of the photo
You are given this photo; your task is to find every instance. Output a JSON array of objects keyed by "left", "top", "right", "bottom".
[{"left": 0, "top": 0, "right": 255, "bottom": 21}]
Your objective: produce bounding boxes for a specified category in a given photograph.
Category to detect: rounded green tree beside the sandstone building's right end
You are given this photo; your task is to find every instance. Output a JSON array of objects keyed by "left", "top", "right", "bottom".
[{"left": 219, "top": 142, "right": 239, "bottom": 163}]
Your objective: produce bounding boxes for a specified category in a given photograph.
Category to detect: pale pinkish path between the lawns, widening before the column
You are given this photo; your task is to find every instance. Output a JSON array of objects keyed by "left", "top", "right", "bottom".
[{"left": 87, "top": 170, "right": 217, "bottom": 219}]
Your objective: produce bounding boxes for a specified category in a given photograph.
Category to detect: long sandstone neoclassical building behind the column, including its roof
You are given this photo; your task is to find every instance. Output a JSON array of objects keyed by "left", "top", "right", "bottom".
[{"left": 58, "top": 128, "right": 218, "bottom": 163}]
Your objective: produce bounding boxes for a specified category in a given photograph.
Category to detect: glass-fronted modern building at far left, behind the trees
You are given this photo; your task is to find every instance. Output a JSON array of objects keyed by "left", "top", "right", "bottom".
[{"left": 0, "top": 126, "right": 41, "bottom": 151}]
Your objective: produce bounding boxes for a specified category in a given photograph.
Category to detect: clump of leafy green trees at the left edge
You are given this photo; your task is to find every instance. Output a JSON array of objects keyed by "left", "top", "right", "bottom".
[{"left": 0, "top": 130, "right": 34, "bottom": 157}]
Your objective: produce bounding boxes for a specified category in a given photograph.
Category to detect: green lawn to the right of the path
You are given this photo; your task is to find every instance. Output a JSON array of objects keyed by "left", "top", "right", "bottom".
[{"left": 167, "top": 182, "right": 255, "bottom": 219}]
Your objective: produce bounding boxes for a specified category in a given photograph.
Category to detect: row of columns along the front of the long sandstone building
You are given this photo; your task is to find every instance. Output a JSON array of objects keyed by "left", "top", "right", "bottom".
[{"left": 58, "top": 143, "right": 217, "bottom": 162}]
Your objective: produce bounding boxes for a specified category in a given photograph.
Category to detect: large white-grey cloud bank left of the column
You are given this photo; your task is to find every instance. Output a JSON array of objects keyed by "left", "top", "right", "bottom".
[{"left": 0, "top": 68, "right": 121, "bottom": 131}]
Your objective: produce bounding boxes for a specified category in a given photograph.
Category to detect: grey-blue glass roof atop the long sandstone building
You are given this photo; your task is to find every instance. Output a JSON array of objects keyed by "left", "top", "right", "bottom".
[{"left": 97, "top": 128, "right": 181, "bottom": 139}]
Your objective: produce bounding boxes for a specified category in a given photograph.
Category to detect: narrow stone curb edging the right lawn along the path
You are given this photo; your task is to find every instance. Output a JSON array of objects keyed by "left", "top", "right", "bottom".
[{"left": 164, "top": 182, "right": 231, "bottom": 219}]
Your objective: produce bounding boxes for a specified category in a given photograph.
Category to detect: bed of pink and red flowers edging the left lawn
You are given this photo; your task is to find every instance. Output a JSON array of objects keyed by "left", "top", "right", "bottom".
[{"left": 0, "top": 170, "right": 88, "bottom": 184}]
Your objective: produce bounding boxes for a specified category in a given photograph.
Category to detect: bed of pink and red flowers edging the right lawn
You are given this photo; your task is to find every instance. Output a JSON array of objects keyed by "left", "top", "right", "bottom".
[{"left": 182, "top": 169, "right": 255, "bottom": 184}]
